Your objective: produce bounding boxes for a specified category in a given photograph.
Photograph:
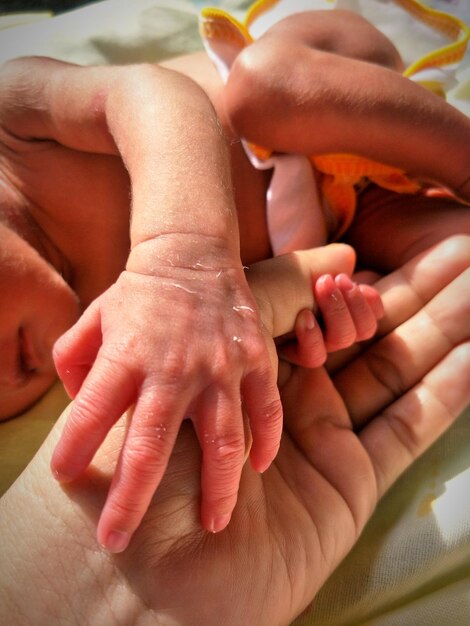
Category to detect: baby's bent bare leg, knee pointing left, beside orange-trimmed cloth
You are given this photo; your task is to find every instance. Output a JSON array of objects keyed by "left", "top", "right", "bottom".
[{"left": 225, "top": 11, "right": 470, "bottom": 200}]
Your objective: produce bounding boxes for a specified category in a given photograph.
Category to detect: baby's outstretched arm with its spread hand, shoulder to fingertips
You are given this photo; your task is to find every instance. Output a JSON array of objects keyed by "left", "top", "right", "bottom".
[{"left": 0, "top": 58, "right": 282, "bottom": 551}]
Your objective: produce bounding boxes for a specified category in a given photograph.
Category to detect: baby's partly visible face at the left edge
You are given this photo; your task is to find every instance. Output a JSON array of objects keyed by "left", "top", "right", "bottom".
[{"left": 0, "top": 223, "right": 79, "bottom": 420}]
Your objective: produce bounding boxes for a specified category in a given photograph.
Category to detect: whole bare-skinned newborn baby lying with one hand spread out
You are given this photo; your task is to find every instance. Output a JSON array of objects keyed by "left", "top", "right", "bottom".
[{"left": 0, "top": 4, "right": 470, "bottom": 552}]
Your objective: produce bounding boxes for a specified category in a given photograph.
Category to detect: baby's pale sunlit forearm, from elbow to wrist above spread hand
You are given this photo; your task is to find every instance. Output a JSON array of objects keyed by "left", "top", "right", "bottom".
[{"left": 106, "top": 66, "right": 242, "bottom": 265}]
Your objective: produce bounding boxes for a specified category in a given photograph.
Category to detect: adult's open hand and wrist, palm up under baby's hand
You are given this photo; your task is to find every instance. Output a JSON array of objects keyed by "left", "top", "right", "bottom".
[{"left": 0, "top": 238, "right": 470, "bottom": 626}]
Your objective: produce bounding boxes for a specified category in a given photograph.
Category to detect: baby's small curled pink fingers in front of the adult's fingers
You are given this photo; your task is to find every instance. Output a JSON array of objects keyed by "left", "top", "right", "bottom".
[{"left": 279, "top": 274, "right": 384, "bottom": 367}]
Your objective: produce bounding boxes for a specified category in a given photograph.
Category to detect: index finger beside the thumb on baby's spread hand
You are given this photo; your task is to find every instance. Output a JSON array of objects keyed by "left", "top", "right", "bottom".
[{"left": 51, "top": 357, "right": 136, "bottom": 482}]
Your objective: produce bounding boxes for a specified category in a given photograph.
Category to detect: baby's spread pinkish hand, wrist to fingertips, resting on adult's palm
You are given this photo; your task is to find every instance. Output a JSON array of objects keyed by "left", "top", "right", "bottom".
[{"left": 52, "top": 264, "right": 282, "bottom": 552}]
